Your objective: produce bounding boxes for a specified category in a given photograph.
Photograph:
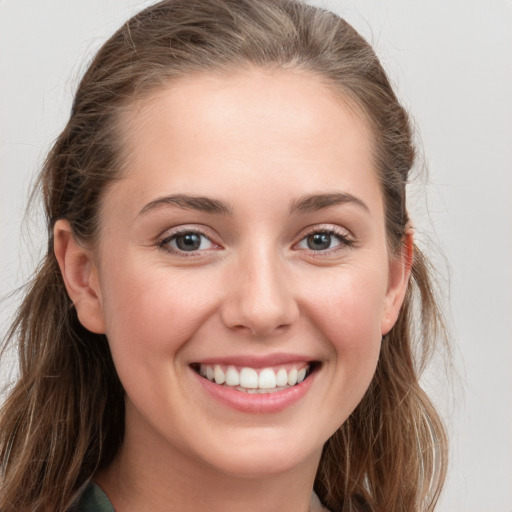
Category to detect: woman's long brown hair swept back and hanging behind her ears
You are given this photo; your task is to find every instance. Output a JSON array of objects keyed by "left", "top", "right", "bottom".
[{"left": 0, "top": 0, "right": 446, "bottom": 512}]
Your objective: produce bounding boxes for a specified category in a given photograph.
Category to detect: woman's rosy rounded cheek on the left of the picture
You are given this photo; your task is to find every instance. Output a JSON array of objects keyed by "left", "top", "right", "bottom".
[{"left": 99, "top": 266, "right": 219, "bottom": 364}]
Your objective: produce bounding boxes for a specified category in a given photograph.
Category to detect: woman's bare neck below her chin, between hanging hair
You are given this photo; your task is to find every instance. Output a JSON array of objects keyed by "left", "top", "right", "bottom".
[{"left": 96, "top": 410, "right": 321, "bottom": 512}]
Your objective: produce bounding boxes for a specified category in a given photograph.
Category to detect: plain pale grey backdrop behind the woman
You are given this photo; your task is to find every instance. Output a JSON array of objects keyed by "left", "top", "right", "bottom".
[{"left": 0, "top": 0, "right": 512, "bottom": 512}]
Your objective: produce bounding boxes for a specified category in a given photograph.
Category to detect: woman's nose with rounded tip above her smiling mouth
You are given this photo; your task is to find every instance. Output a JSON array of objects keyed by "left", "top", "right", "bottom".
[{"left": 221, "top": 246, "right": 299, "bottom": 337}]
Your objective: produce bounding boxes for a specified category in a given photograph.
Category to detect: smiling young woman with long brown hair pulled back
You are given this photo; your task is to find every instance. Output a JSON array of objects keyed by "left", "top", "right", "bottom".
[{"left": 0, "top": 0, "right": 446, "bottom": 512}]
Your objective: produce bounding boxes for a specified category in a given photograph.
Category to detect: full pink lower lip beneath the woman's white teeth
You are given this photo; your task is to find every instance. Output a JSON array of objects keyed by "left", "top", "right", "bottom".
[{"left": 192, "top": 370, "right": 317, "bottom": 414}]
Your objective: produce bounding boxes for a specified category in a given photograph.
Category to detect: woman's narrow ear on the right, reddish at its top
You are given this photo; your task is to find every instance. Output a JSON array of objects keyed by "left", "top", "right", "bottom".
[{"left": 381, "top": 228, "right": 414, "bottom": 336}]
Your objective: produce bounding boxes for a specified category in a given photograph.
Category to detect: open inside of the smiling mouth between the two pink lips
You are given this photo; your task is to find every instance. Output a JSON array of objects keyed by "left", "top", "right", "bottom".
[{"left": 190, "top": 361, "right": 320, "bottom": 394}]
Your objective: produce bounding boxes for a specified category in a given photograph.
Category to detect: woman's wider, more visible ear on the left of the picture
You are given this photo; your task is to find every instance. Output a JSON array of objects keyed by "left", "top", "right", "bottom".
[{"left": 53, "top": 220, "right": 105, "bottom": 334}]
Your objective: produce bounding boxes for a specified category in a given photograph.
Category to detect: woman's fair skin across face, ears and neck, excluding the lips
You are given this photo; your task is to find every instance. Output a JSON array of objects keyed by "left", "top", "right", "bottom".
[{"left": 55, "top": 69, "right": 412, "bottom": 512}]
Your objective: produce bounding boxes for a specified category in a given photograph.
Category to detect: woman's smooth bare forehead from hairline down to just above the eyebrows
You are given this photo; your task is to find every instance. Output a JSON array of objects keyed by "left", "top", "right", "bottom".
[{"left": 107, "top": 69, "right": 377, "bottom": 216}]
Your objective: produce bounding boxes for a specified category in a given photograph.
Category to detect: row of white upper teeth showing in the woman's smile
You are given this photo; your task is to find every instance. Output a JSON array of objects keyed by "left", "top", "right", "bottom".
[{"left": 199, "top": 364, "right": 309, "bottom": 390}]
